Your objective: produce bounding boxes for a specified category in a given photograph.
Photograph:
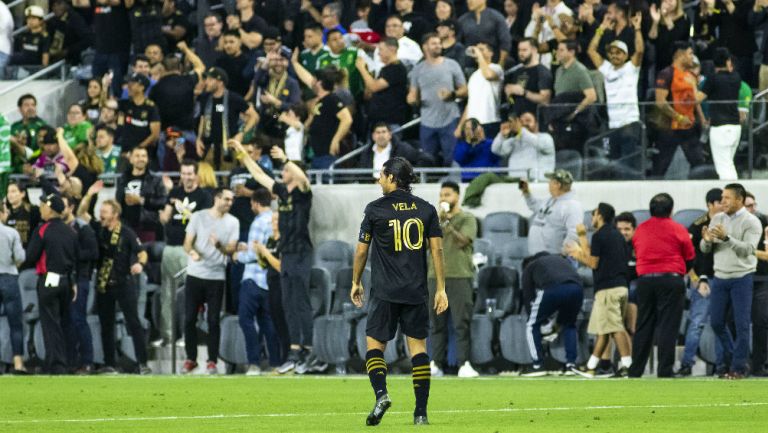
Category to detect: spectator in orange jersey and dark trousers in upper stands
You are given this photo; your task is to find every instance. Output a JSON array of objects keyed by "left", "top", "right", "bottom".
[{"left": 651, "top": 41, "right": 704, "bottom": 177}]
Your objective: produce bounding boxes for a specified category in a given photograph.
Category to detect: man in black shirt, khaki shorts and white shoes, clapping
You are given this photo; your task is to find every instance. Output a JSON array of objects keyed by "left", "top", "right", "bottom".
[{"left": 567, "top": 203, "right": 632, "bottom": 378}]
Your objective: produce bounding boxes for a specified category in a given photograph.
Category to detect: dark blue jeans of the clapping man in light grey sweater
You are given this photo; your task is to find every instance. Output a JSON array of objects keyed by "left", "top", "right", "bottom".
[{"left": 709, "top": 274, "right": 754, "bottom": 374}]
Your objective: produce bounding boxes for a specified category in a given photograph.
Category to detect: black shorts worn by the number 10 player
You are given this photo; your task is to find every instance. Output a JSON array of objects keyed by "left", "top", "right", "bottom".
[{"left": 365, "top": 297, "right": 429, "bottom": 343}]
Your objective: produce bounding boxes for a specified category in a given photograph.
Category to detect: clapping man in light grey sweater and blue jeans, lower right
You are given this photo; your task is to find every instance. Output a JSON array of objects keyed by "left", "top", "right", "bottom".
[{"left": 701, "top": 183, "right": 763, "bottom": 379}]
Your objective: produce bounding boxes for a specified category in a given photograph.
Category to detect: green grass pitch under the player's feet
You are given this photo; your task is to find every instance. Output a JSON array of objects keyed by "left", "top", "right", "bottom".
[{"left": 0, "top": 376, "right": 768, "bottom": 433}]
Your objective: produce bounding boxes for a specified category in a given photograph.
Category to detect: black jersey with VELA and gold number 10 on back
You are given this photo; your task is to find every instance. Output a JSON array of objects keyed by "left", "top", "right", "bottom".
[{"left": 359, "top": 190, "right": 443, "bottom": 304}]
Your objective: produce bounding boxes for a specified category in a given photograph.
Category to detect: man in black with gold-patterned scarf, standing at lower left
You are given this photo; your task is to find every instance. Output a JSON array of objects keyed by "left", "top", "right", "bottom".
[{"left": 96, "top": 199, "right": 152, "bottom": 374}]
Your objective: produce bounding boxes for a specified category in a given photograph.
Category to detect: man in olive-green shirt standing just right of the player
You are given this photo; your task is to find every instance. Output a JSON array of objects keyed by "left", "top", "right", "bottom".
[{"left": 427, "top": 181, "right": 479, "bottom": 377}]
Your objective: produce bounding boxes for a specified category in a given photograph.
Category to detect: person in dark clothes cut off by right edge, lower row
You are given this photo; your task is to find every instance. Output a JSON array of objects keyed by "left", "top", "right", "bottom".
[{"left": 744, "top": 191, "right": 768, "bottom": 377}]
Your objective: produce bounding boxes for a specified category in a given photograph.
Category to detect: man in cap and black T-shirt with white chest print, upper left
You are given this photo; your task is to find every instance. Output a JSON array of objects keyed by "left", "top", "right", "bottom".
[{"left": 117, "top": 74, "right": 160, "bottom": 157}]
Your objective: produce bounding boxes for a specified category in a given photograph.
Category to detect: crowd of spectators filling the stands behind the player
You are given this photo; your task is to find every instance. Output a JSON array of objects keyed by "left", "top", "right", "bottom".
[{"left": 0, "top": 0, "right": 768, "bottom": 377}]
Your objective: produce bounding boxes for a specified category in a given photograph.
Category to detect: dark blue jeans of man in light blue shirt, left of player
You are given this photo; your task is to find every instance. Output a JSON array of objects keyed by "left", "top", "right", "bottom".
[{"left": 237, "top": 279, "right": 280, "bottom": 366}]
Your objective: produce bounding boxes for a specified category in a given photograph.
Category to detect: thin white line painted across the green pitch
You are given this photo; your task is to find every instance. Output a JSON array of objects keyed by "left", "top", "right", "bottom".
[{"left": 0, "top": 402, "right": 768, "bottom": 425}]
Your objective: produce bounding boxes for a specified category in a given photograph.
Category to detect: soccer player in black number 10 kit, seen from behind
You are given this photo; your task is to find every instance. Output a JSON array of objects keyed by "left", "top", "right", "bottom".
[{"left": 350, "top": 157, "right": 448, "bottom": 425}]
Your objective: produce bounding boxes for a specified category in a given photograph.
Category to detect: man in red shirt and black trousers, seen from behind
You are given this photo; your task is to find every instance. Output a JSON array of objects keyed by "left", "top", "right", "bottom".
[{"left": 629, "top": 193, "right": 696, "bottom": 377}]
